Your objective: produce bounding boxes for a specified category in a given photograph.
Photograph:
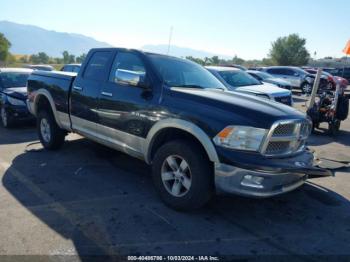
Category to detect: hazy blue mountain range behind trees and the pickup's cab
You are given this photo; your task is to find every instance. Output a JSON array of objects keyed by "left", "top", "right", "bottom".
[{"left": 0, "top": 21, "right": 230, "bottom": 59}]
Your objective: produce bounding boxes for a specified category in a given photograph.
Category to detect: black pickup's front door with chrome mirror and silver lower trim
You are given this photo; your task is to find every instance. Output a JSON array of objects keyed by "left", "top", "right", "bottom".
[{"left": 97, "top": 51, "right": 157, "bottom": 156}]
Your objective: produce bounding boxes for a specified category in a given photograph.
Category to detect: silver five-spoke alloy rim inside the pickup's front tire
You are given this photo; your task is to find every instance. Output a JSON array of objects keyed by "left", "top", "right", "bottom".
[{"left": 161, "top": 155, "right": 192, "bottom": 197}]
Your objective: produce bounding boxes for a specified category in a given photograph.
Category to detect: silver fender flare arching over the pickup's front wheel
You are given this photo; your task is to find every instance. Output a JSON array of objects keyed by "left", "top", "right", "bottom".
[{"left": 144, "top": 119, "right": 219, "bottom": 164}]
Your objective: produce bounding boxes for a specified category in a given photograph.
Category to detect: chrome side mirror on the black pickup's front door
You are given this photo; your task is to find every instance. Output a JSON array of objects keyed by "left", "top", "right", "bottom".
[{"left": 114, "top": 69, "right": 150, "bottom": 89}]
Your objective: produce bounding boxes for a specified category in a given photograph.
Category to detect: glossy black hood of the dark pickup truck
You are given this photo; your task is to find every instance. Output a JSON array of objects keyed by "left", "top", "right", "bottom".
[{"left": 169, "top": 88, "right": 306, "bottom": 128}]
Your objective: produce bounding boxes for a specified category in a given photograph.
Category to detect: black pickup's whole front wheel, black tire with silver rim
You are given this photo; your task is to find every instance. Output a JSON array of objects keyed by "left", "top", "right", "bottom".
[{"left": 152, "top": 140, "right": 214, "bottom": 211}]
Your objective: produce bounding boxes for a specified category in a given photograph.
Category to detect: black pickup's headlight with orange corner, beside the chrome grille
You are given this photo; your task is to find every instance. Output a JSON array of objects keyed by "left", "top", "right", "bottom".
[{"left": 214, "top": 126, "right": 268, "bottom": 151}]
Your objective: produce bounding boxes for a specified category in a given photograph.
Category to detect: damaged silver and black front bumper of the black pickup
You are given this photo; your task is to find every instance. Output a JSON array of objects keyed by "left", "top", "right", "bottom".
[{"left": 215, "top": 149, "right": 332, "bottom": 197}]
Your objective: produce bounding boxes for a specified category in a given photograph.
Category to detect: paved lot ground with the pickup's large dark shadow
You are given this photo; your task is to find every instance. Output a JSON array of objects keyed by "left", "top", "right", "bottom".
[{"left": 0, "top": 96, "right": 350, "bottom": 260}]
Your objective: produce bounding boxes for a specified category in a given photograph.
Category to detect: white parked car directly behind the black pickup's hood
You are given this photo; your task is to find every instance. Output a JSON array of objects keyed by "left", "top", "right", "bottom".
[{"left": 206, "top": 66, "right": 293, "bottom": 106}]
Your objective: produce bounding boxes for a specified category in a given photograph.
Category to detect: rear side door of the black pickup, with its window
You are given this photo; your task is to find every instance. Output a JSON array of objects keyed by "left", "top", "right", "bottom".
[{"left": 70, "top": 50, "right": 114, "bottom": 137}]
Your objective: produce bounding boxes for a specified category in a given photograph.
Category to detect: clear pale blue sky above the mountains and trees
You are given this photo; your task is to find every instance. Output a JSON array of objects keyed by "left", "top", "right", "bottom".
[{"left": 0, "top": 0, "right": 350, "bottom": 59}]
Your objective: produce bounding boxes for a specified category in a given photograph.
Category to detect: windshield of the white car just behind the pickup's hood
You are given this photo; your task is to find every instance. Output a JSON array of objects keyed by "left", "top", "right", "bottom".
[{"left": 218, "top": 70, "right": 261, "bottom": 87}]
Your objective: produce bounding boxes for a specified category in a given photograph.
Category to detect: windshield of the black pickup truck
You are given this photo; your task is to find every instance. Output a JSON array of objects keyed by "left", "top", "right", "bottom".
[{"left": 149, "top": 54, "right": 225, "bottom": 89}]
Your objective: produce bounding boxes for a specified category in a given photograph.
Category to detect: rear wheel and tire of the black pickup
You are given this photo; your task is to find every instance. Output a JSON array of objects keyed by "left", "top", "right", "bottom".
[{"left": 37, "top": 108, "right": 66, "bottom": 150}]
